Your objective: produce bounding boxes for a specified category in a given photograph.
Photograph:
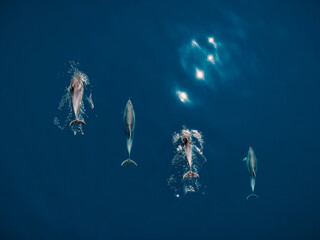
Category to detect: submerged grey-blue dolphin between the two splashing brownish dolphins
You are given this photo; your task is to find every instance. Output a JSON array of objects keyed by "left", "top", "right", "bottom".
[{"left": 121, "top": 98, "right": 137, "bottom": 166}]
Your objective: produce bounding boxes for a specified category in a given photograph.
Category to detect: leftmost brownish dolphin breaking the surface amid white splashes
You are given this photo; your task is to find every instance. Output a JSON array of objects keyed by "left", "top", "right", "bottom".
[{"left": 69, "top": 74, "right": 86, "bottom": 126}]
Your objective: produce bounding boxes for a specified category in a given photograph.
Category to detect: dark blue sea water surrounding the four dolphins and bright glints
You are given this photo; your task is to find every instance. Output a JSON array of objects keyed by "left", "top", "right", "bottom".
[{"left": 0, "top": 1, "right": 320, "bottom": 240}]
